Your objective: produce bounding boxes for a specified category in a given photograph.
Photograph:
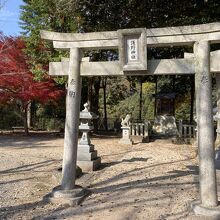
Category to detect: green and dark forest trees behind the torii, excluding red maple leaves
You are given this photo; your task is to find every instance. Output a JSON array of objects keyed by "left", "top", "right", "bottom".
[{"left": 0, "top": 0, "right": 220, "bottom": 130}]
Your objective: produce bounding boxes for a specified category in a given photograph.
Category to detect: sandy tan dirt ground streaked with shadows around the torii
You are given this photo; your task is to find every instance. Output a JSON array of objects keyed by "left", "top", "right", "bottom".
[{"left": 0, "top": 133, "right": 210, "bottom": 220}]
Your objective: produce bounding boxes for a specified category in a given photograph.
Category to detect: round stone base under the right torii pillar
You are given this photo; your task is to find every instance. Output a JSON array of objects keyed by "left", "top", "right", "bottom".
[{"left": 191, "top": 201, "right": 220, "bottom": 219}]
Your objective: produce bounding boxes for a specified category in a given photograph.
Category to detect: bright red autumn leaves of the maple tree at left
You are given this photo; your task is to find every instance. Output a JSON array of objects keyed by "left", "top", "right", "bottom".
[{"left": 0, "top": 35, "right": 63, "bottom": 108}]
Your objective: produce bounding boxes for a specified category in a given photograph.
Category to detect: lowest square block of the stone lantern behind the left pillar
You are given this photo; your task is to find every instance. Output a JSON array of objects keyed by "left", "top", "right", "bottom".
[{"left": 77, "top": 157, "right": 101, "bottom": 172}]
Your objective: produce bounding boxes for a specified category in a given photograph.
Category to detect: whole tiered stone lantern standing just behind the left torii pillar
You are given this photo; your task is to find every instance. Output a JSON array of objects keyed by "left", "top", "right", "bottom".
[{"left": 77, "top": 103, "right": 101, "bottom": 172}]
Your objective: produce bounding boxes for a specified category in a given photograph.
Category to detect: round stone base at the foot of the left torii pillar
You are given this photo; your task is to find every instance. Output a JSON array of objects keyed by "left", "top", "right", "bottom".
[{"left": 44, "top": 185, "right": 91, "bottom": 206}]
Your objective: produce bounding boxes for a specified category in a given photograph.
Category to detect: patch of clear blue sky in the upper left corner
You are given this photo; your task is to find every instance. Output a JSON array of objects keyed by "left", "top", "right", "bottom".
[{"left": 0, "top": 0, "right": 23, "bottom": 36}]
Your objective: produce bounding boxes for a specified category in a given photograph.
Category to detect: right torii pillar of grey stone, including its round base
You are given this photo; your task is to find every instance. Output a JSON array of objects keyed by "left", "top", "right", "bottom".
[{"left": 193, "top": 41, "right": 220, "bottom": 216}]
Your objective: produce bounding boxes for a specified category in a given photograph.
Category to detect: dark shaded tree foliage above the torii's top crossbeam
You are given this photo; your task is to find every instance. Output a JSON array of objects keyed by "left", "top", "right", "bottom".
[{"left": 76, "top": 0, "right": 220, "bottom": 32}]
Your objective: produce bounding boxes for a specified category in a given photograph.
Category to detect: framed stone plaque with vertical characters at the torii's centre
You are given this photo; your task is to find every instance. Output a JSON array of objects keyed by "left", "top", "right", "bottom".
[{"left": 118, "top": 28, "right": 147, "bottom": 72}]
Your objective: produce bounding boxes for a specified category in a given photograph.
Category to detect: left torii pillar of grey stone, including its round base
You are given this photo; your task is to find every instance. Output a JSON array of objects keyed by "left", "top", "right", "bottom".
[{"left": 50, "top": 48, "right": 89, "bottom": 206}]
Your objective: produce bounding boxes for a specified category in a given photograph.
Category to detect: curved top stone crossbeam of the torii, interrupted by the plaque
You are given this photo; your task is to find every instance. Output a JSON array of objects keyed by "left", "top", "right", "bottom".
[{"left": 41, "top": 22, "right": 220, "bottom": 49}]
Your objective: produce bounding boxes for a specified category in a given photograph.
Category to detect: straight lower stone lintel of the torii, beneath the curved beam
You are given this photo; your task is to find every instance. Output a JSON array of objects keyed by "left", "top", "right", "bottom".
[{"left": 49, "top": 53, "right": 220, "bottom": 76}]
